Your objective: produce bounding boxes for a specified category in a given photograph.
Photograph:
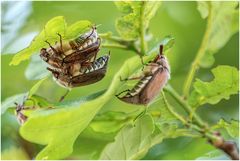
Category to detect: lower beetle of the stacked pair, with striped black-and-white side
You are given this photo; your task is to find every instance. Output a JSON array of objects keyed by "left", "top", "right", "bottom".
[{"left": 48, "top": 54, "right": 110, "bottom": 89}]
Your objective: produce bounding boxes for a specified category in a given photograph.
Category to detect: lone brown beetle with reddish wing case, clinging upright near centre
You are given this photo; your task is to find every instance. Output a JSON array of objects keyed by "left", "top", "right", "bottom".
[{"left": 116, "top": 45, "right": 170, "bottom": 105}]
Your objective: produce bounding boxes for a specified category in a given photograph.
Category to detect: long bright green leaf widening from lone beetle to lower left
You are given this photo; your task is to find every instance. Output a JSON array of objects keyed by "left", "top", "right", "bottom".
[{"left": 20, "top": 36, "right": 174, "bottom": 159}]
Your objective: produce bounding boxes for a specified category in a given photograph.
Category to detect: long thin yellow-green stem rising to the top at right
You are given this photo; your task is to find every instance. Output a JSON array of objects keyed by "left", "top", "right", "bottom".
[{"left": 183, "top": 4, "right": 212, "bottom": 99}]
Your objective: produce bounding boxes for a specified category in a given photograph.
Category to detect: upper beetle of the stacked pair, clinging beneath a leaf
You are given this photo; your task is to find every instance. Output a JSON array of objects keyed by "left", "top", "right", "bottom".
[{"left": 40, "top": 27, "right": 101, "bottom": 72}]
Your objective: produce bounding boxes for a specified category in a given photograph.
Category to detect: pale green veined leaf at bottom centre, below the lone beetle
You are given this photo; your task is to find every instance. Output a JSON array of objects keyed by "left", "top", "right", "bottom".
[{"left": 100, "top": 115, "right": 154, "bottom": 160}]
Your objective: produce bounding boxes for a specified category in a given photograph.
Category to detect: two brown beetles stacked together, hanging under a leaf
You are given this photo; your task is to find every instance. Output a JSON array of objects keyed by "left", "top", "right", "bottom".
[{"left": 40, "top": 27, "right": 110, "bottom": 88}]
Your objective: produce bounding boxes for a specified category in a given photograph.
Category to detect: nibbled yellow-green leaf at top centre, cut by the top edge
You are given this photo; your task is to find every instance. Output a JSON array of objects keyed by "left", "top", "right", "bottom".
[{"left": 115, "top": 1, "right": 161, "bottom": 40}]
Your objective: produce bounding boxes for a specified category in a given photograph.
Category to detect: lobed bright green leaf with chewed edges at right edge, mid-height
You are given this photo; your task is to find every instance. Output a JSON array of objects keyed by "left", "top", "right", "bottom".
[{"left": 188, "top": 65, "right": 239, "bottom": 107}]
